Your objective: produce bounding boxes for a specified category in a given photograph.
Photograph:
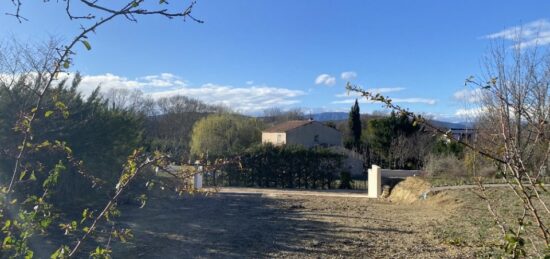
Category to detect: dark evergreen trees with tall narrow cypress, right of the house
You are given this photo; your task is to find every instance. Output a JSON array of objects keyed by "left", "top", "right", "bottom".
[{"left": 338, "top": 101, "right": 463, "bottom": 169}]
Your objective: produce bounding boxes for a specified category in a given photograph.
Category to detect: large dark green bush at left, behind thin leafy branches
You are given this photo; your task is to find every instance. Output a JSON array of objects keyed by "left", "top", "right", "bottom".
[{"left": 0, "top": 75, "right": 144, "bottom": 205}]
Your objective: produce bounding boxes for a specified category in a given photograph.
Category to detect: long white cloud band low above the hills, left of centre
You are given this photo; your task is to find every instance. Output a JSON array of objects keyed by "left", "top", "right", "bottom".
[{"left": 66, "top": 73, "right": 306, "bottom": 113}]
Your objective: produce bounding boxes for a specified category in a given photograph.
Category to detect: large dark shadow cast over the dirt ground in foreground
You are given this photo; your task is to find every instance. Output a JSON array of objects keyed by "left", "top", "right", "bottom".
[{"left": 113, "top": 194, "right": 368, "bottom": 258}]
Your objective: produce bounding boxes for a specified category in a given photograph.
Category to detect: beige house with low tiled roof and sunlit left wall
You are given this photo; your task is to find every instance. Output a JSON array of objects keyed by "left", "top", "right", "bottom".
[{"left": 262, "top": 120, "right": 342, "bottom": 147}]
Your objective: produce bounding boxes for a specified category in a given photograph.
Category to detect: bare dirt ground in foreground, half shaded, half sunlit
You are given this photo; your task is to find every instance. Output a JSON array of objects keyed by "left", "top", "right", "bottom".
[{"left": 113, "top": 190, "right": 480, "bottom": 258}]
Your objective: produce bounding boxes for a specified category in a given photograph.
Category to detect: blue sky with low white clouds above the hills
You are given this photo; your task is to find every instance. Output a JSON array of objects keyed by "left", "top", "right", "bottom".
[{"left": 0, "top": 0, "right": 550, "bottom": 121}]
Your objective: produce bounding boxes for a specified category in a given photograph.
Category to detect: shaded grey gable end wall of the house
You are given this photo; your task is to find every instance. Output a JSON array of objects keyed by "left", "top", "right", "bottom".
[{"left": 286, "top": 122, "right": 342, "bottom": 147}]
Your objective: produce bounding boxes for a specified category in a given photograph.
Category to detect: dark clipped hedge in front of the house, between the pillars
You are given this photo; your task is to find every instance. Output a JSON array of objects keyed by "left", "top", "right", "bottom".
[{"left": 215, "top": 144, "right": 343, "bottom": 189}]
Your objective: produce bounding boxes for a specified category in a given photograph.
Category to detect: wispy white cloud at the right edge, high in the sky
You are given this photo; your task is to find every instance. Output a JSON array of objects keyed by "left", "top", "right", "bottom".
[{"left": 483, "top": 19, "right": 550, "bottom": 48}]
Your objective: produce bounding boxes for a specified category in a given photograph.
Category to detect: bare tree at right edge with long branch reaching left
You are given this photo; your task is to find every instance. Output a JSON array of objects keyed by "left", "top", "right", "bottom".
[{"left": 347, "top": 39, "right": 550, "bottom": 257}]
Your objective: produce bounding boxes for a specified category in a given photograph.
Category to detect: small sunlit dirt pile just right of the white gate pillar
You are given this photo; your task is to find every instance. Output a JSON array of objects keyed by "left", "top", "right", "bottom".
[{"left": 389, "top": 177, "right": 431, "bottom": 203}]
